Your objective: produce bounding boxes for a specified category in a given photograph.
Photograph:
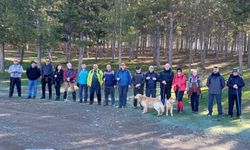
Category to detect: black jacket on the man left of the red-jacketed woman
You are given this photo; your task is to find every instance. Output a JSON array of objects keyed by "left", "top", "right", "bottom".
[{"left": 159, "top": 69, "right": 174, "bottom": 89}]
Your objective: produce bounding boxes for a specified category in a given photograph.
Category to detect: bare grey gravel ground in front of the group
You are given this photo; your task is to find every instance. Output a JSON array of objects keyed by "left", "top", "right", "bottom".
[{"left": 0, "top": 98, "right": 250, "bottom": 150}]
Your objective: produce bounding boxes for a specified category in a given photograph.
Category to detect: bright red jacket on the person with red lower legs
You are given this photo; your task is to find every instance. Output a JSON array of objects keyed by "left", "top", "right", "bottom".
[{"left": 173, "top": 73, "right": 186, "bottom": 91}]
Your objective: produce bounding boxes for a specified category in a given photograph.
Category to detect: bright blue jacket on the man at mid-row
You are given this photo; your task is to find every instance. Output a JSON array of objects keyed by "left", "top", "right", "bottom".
[{"left": 115, "top": 69, "right": 131, "bottom": 86}]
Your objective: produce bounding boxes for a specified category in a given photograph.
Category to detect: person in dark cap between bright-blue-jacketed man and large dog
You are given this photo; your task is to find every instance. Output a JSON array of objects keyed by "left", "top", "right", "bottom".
[{"left": 132, "top": 66, "right": 145, "bottom": 108}]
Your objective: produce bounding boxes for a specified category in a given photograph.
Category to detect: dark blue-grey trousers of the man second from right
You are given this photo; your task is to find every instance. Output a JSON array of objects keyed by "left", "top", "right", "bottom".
[{"left": 208, "top": 94, "right": 222, "bottom": 115}]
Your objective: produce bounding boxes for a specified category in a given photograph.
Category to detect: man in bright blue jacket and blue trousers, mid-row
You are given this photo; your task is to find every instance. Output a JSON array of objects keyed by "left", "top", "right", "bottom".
[{"left": 115, "top": 63, "right": 131, "bottom": 108}]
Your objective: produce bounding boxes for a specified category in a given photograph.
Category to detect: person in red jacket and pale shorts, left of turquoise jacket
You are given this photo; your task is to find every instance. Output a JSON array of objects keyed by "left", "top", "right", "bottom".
[{"left": 63, "top": 63, "right": 77, "bottom": 101}]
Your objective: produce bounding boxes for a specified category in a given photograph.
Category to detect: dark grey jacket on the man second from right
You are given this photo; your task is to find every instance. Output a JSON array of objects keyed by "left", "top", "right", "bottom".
[{"left": 207, "top": 73, "right": 225, "bottom": 94}]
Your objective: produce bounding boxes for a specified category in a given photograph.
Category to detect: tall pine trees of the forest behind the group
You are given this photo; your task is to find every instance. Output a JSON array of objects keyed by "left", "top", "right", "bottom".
[{"left": 0, "top": 0, "right": 250, "bottom": 72}]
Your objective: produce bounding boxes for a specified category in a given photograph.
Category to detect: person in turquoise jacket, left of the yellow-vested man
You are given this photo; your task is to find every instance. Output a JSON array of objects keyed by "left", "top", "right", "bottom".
[{"left": 77, "top": 64, "right": 89, "bottom": 103}]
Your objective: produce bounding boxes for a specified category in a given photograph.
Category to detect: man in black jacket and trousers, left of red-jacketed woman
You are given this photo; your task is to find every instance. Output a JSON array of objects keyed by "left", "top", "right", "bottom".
[{"left": 159, "top": 63, "right": 174, "bottom": 104}]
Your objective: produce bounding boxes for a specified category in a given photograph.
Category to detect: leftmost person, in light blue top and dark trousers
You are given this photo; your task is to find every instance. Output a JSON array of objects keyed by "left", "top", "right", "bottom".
[{"left": 8, "top": 59, "right": 23, "bottom": 98}]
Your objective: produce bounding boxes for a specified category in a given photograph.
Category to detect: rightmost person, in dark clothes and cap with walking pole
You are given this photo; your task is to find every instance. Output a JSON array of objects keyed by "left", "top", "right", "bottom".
[{"left": 227, "top": 69, "right": 245, "bottom": 118}]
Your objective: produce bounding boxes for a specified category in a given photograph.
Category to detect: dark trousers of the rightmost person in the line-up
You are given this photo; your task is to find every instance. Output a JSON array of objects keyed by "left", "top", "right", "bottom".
[{"left": 228, "top": 94, "right": 241, "bottom": 117}]
